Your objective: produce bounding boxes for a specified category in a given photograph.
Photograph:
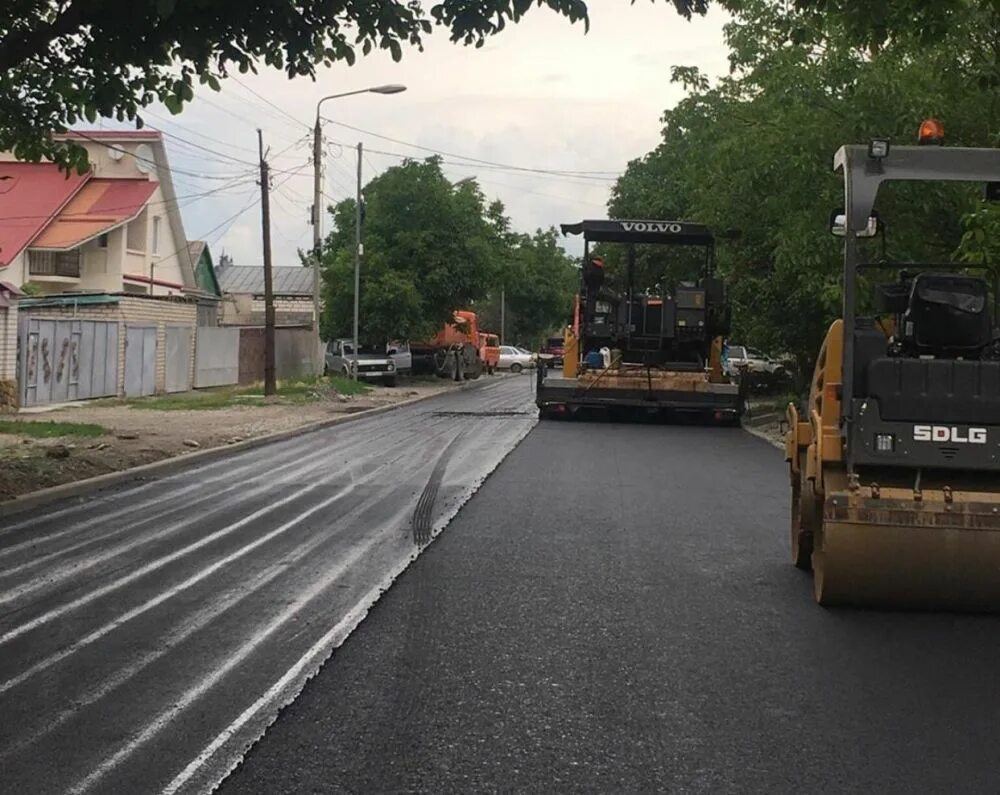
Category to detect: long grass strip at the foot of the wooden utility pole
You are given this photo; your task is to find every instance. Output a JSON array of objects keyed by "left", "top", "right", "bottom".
[{"left": 96, "top": 376, "right": 371, "bottom": 411}]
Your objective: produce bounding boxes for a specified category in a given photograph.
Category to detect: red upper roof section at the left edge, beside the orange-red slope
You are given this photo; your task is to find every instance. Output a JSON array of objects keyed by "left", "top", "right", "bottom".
[{"left": 0, "top": 162, "right": 89, "bottom": 268}]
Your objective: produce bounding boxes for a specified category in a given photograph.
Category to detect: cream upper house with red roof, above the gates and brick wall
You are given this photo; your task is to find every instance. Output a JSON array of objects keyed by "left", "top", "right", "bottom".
[{"left": 0, "top": 130, "right": 197, "bottom": 295}]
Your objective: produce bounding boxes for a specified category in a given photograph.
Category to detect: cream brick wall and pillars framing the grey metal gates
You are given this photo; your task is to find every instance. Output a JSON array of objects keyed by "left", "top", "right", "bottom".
[{"left": 22, "top": 296, "right": 198, "bottom": 396}]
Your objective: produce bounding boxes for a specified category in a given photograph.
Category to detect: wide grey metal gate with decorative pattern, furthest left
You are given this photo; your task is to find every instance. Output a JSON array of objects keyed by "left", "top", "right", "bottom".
[{"left": 18, "top": 315, "right": 118, "bottom": 406}]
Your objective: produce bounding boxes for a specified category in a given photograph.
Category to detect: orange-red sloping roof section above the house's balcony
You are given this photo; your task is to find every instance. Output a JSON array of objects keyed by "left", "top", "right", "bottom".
[{"left": 32, "top": 179, "right": 158, "bottom": 250}]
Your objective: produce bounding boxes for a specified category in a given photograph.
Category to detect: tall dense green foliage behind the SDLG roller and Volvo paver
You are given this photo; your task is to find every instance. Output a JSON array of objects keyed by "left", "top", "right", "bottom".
[{"left": 609, "top": 0, "right": 1000, "bottom": 364}]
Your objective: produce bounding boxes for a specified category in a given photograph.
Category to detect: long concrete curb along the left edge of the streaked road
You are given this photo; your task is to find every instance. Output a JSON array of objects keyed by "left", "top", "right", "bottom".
[{"left": 0, "top": 380, "right": 502, "bottom": 519}]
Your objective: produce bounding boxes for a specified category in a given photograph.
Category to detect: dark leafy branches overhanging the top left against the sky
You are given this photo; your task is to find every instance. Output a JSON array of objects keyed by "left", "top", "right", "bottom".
[{"left": 0, "top": 0, "right": 706, "bottom": 169}]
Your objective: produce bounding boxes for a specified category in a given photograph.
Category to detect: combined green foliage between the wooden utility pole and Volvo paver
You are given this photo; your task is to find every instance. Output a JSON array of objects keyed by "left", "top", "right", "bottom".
[{"left": 322, "top": 162, "right": 578, "bottom": 346}]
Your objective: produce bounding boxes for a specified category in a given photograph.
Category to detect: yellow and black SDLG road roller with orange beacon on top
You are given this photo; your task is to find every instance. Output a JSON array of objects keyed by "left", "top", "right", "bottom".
[{"left": 785, "top": 120, "right": 1000, "bottom": 611}]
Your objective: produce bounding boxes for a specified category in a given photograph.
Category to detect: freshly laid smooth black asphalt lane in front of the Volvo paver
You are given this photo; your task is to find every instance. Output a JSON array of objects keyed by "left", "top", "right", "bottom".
[{"left": 221, "top": 422, "right": 1000, "bottom": 795}]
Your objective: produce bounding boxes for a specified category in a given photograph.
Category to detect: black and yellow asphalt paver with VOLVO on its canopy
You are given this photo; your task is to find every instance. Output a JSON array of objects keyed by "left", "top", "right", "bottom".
[{"left": 536, "top": 220, "right": 743, "bottom": 424}]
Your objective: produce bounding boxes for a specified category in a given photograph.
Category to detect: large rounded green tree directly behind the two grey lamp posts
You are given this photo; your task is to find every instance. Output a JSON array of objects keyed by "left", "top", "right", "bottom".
[{"left": 323, "top": 157, "right": 504, "bottom": 345}]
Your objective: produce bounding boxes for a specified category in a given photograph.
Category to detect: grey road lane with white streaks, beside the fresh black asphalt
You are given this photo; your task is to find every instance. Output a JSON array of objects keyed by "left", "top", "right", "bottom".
[{"left": 0, "top": 377, "right": 536, "bottom": 795}]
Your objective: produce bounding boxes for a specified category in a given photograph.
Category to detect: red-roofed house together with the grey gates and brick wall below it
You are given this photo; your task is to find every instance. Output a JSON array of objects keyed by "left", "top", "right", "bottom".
[{"left": 0, "top": 130, "right": 218, "bottom": 407}]
